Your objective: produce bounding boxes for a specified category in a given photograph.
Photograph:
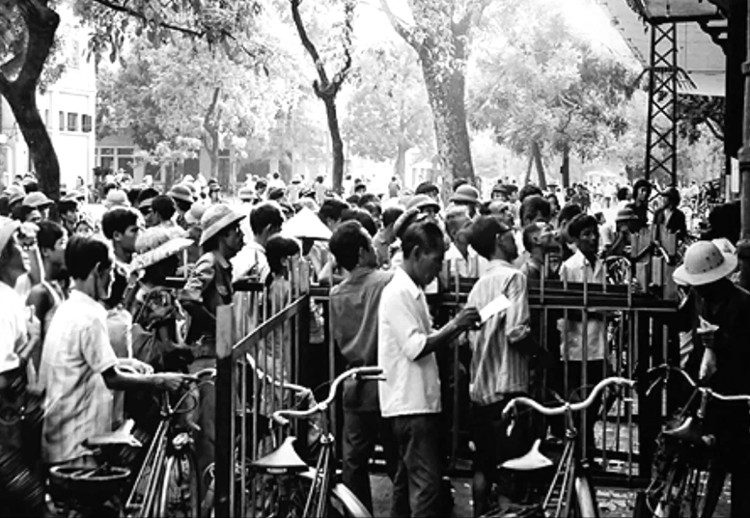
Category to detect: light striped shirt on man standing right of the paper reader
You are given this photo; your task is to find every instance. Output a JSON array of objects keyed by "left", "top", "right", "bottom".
[{"left": 466, "top": 259, "right": 530, "bottom": 405}]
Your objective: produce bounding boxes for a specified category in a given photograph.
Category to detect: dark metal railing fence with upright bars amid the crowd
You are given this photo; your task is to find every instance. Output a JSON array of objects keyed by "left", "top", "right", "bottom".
[{"left": 215, "top": 248, "right": 679, "bottom": 516}]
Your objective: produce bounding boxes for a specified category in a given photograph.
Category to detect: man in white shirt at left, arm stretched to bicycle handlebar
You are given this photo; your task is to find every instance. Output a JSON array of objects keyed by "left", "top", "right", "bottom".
[{"left": 39, "top": 236, "right": 191, "bottom": 466}]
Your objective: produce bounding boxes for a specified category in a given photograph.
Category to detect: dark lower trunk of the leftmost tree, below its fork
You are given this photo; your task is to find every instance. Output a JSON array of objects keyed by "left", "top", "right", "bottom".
[{"left": 6, "top": 86, "right": 60, "bottom": 200}]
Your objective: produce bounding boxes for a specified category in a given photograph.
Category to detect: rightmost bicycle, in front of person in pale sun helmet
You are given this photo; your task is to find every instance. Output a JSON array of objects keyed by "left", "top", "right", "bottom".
[{"left": 636, "top": 364, "right": 750, "bottom": 518}]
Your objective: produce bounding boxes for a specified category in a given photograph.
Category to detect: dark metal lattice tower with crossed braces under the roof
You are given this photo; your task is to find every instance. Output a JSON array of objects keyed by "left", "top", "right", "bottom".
[{"left": 645, "top": 23, "right": 679, "bottom": 189}]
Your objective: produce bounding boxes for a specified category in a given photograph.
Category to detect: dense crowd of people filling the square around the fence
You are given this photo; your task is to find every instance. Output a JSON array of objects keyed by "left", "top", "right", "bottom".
[{"left": 0, "top": 169, "right": 750, "bottom": 516}]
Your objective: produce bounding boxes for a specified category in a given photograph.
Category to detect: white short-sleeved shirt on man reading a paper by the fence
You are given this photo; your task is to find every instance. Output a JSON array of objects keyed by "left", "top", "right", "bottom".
[{"left": 378, "top": 268, "right": 441, "bottom": 417}]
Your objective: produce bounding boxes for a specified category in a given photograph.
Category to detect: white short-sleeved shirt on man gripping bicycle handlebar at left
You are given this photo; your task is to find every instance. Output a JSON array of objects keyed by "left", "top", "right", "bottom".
[{"left": 39, "top": 290, "right": 117, "bottom": 463}]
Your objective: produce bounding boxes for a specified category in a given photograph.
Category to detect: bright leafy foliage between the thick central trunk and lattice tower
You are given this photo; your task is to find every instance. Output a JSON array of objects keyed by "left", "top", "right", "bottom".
[{"left": 470, "top": 0, "right": 636, "bottom": 185}]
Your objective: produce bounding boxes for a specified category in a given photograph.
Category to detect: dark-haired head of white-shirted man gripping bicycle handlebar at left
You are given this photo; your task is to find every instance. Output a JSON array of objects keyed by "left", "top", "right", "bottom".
[{"left": 65, "top": 236, "right": 114, "bottom": 300}]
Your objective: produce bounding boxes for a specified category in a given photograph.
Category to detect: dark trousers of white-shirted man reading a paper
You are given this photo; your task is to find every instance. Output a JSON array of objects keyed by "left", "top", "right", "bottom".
[{"left": 390, "top": 414, "right": 445, "bottom": 518}]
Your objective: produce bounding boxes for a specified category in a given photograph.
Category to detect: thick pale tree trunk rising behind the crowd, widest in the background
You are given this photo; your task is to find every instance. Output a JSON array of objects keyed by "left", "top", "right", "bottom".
[{"left": 420, "top": 54, "right": 474, "bottom": 184}]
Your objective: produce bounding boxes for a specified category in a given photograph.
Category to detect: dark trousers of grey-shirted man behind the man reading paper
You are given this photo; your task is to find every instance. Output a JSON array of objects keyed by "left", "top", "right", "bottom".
[{"left": 342, "top": 409, "right": 396, "bottom": 513}]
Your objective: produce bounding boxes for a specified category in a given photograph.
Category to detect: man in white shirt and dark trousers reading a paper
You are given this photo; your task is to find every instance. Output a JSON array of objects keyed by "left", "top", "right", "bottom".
[{"left": 378, "top": 218, "right": 479, "bottom": 516}]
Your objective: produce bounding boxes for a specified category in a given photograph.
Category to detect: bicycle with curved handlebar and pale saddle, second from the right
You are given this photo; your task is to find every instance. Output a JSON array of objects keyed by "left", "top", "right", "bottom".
[{"left": 496, "top": 377, "right": 635, "bottom": 518}]
